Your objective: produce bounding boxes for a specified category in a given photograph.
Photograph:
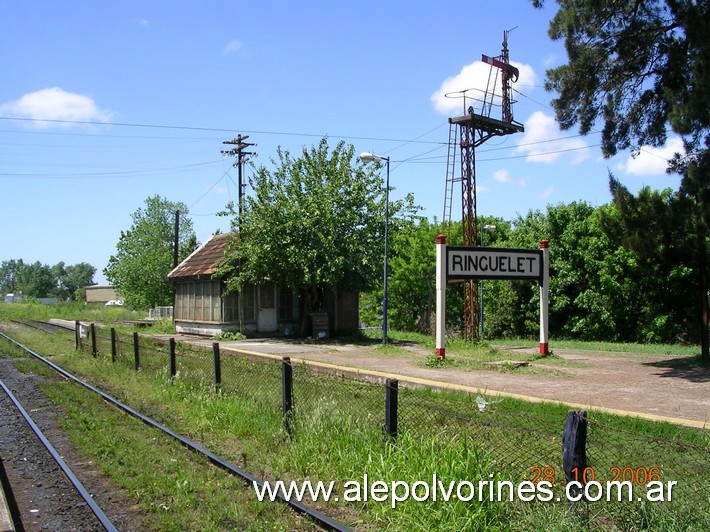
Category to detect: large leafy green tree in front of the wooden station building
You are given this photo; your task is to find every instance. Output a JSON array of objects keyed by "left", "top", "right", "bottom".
[{"left": 218, "top": 138, "right": 413, "bottom": 330}]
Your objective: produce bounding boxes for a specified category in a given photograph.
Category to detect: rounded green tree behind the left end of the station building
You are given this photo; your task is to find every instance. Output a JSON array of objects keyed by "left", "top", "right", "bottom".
[{"left": 104, "top": 195, "right": 197, "bottom": 309}]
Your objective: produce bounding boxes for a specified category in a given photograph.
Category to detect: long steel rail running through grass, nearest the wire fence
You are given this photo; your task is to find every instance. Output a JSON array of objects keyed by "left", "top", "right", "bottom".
[{"left": 0, "top": 332, "right": 348, "bottom": 531}]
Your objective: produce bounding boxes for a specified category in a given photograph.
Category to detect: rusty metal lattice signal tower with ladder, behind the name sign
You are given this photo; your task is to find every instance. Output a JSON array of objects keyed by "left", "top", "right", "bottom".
[{"left": 442, "top": 31, "right": 524, "bottom": 340}]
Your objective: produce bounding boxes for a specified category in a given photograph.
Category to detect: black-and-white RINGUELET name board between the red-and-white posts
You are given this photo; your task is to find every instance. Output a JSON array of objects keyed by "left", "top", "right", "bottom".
[{"left": 446, "top": 246, "right": 543, "bottom": 281}]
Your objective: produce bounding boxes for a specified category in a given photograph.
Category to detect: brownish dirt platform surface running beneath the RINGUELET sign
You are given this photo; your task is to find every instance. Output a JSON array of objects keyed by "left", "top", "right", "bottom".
[{"left": 202, "top": 340, "right": 710, "bottom": 428}]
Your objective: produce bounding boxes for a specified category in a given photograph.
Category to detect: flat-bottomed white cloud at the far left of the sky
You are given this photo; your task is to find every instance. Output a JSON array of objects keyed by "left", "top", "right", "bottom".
[{"left": 0, "top": 87, "right": 113, "bottom": 127}]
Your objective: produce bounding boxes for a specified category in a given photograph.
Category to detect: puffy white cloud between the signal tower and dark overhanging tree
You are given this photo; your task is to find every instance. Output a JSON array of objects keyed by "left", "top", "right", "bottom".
[{"left": 516, "top": 111, "right": 590, "bottom": 164}]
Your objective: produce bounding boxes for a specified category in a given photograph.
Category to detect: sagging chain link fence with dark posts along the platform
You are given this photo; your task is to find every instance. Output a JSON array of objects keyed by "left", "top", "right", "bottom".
[{"left": 79, "top": 327, "right": 710, "bottom": 512}]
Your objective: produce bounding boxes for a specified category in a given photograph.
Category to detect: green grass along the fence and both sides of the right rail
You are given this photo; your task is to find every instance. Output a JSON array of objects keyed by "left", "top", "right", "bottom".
[{"left": 2, "top": 322, "right": 710, "bottom": 530}]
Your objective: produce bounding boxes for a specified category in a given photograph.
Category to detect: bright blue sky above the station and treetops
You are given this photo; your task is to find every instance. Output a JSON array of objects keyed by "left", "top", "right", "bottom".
[{"left": 0, "top": 0, "right": 681, "bottom": 283}]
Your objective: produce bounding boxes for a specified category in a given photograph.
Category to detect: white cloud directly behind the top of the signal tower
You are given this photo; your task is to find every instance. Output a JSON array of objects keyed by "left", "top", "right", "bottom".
[{"left": 431, "top": 61, "right": 536, "bottom": 116}]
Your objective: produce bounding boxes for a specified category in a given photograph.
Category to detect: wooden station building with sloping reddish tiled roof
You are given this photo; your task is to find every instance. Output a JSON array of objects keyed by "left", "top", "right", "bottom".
[{"left": 168, "top": 234, "right": 358, "bottom": 337}]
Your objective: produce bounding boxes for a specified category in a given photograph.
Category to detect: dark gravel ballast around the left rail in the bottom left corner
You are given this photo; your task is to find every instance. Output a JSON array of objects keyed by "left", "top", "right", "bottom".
[{"left": 0, "top": 353, "right": 142, "bottom": 531}]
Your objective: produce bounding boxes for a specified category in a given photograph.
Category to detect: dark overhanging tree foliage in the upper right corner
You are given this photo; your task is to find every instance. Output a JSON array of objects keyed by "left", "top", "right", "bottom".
[{"left": 533, "top": 0, "right": 710, "bottom": 359}]
